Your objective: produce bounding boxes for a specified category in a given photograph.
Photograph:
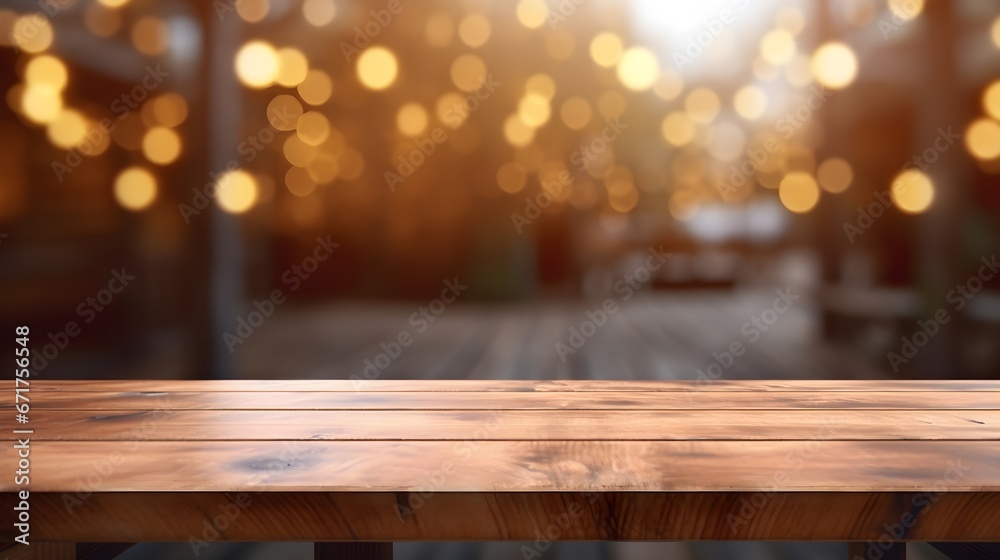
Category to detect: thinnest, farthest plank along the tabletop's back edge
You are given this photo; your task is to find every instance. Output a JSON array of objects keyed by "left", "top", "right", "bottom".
[{"left": 15, "top": 379, "right": 1000, "bottom": 393}]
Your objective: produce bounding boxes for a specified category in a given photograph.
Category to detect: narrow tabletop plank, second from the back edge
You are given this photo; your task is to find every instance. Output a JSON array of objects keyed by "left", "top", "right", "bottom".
[{"left": 0, "top": 391, "right": 1000, "bottom": 412}]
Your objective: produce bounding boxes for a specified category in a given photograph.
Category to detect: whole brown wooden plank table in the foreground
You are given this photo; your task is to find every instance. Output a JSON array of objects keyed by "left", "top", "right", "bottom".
[{"left": 0, "top": 380, "right": 1000, "bottom": 560}]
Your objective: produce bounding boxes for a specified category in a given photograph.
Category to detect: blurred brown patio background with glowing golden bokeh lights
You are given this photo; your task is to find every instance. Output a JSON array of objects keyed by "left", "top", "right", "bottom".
[{"left": 0, "top": 0, "right": 1000, "bottom": 559}]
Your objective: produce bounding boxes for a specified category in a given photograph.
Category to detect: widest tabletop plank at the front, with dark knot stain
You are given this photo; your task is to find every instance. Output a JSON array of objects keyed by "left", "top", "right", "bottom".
[{"left": 0, "top": 441, "right": 1000, "bottom": 495}]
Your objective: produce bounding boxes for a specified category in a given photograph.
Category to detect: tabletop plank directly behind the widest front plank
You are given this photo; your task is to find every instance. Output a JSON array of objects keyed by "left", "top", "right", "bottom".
[{"left": 9, "top": 409, "right": 1000, "bottom": 441}]
